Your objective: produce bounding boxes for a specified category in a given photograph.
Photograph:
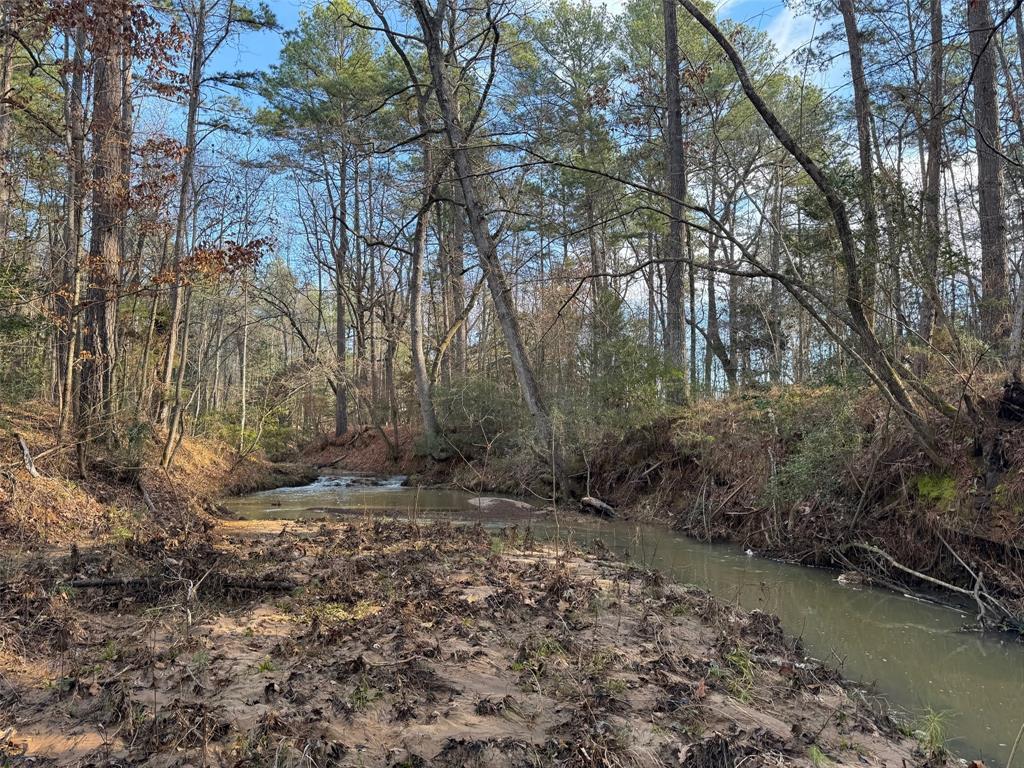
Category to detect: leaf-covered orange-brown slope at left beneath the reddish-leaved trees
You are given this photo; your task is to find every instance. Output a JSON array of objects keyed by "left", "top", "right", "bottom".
[{"left": 0, "top": 401, "right": 313, "bottom": 546}]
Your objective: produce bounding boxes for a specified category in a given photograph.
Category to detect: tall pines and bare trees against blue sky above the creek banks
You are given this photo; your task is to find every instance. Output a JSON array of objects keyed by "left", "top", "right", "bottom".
[{"left": 0, "top": 0, "right": 1024, "bottom": 476}]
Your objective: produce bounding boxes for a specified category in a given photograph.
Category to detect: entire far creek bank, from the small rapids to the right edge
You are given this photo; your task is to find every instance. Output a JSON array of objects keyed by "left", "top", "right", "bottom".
[{"left": 306, "top": 383, "right": 1024, "bottom": 634}]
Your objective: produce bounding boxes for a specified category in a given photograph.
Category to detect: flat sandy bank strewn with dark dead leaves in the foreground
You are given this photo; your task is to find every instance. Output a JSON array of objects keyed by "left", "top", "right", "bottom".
[{"left": 0, "top": 520, "right": 942, "bottom": 766}]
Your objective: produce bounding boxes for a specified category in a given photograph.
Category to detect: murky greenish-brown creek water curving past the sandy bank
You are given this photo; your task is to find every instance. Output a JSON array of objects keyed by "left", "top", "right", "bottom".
[{"left": 223, "top": 475, "right": 1024, "bottom": 766}]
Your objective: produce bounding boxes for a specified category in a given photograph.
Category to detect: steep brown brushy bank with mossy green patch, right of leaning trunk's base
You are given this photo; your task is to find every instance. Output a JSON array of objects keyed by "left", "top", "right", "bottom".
[{"left": 590, "top": 388, "right": 1024, "bottom": 624}]
